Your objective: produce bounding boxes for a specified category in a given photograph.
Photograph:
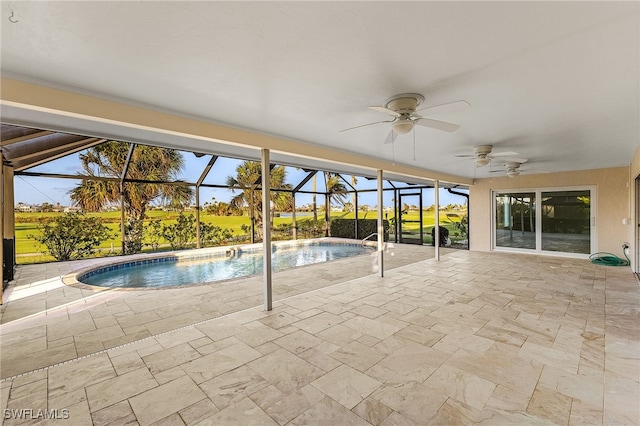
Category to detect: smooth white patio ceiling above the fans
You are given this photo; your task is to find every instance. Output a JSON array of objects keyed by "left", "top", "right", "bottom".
[{"left": 1, "top": 1, "right": 640, "bottom": 178}]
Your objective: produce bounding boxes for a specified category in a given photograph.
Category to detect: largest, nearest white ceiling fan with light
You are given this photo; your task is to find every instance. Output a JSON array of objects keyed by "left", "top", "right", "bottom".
[{"left": 341, "top": 93, "right": 470, "bottom": 143}]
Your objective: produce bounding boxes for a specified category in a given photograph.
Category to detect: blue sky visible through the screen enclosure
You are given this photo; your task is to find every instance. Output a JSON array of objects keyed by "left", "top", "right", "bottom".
[{"left": 14, "top": 148, "right": 466, "bottom": 207}]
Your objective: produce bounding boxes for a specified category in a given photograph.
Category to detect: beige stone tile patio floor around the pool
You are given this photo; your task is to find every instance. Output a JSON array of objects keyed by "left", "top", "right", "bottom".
[{"left": 0, "top": 245, "right": 640, "bottom": 425}]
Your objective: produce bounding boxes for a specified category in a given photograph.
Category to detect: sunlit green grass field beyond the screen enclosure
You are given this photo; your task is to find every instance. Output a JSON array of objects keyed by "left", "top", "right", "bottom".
[{"left": 15, "top": 210, "right": 464, "bottom": 264}]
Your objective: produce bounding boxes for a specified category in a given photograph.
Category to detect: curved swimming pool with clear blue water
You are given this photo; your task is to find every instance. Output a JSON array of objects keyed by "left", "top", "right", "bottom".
[{"left": 76, "top": 240, "right": 372, "bottom": 288}]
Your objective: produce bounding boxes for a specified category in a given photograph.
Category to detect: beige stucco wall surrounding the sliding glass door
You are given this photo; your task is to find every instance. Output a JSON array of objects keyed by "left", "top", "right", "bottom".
[{"left": 469, "top": 166, "right": 640, "bottom": 256}]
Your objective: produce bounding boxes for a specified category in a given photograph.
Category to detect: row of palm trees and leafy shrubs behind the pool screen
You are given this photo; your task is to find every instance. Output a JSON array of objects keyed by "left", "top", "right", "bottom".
[{"left": 30, "top": 141, "right": 347, "bottom": 260}]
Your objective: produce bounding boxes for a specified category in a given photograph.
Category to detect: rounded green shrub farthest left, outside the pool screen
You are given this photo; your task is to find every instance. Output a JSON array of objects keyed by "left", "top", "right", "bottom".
[{"left": 27, "top": 213, "right": 111, "bottom": 261}]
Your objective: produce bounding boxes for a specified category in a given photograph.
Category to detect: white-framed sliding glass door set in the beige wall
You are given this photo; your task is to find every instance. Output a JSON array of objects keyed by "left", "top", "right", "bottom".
[{"left": 493, "top": 187, "right": 595, "bottom": 256}]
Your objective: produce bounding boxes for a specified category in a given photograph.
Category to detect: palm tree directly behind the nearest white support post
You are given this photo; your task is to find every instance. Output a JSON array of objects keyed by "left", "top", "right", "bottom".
[{"left": 226, "top": 161, "right": 293, "bottom": 242}]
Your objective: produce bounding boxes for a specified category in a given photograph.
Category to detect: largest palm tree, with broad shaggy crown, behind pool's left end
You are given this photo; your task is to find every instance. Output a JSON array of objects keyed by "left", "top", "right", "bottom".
[{"left": 70, "top": 141, "right": 193, "bottom": 253}]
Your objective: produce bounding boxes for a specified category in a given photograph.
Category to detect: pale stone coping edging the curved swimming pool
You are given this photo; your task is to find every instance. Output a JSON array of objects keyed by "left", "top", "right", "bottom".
[{"left": 61, "top": 237, "right": 377, "bottom": 291}]
